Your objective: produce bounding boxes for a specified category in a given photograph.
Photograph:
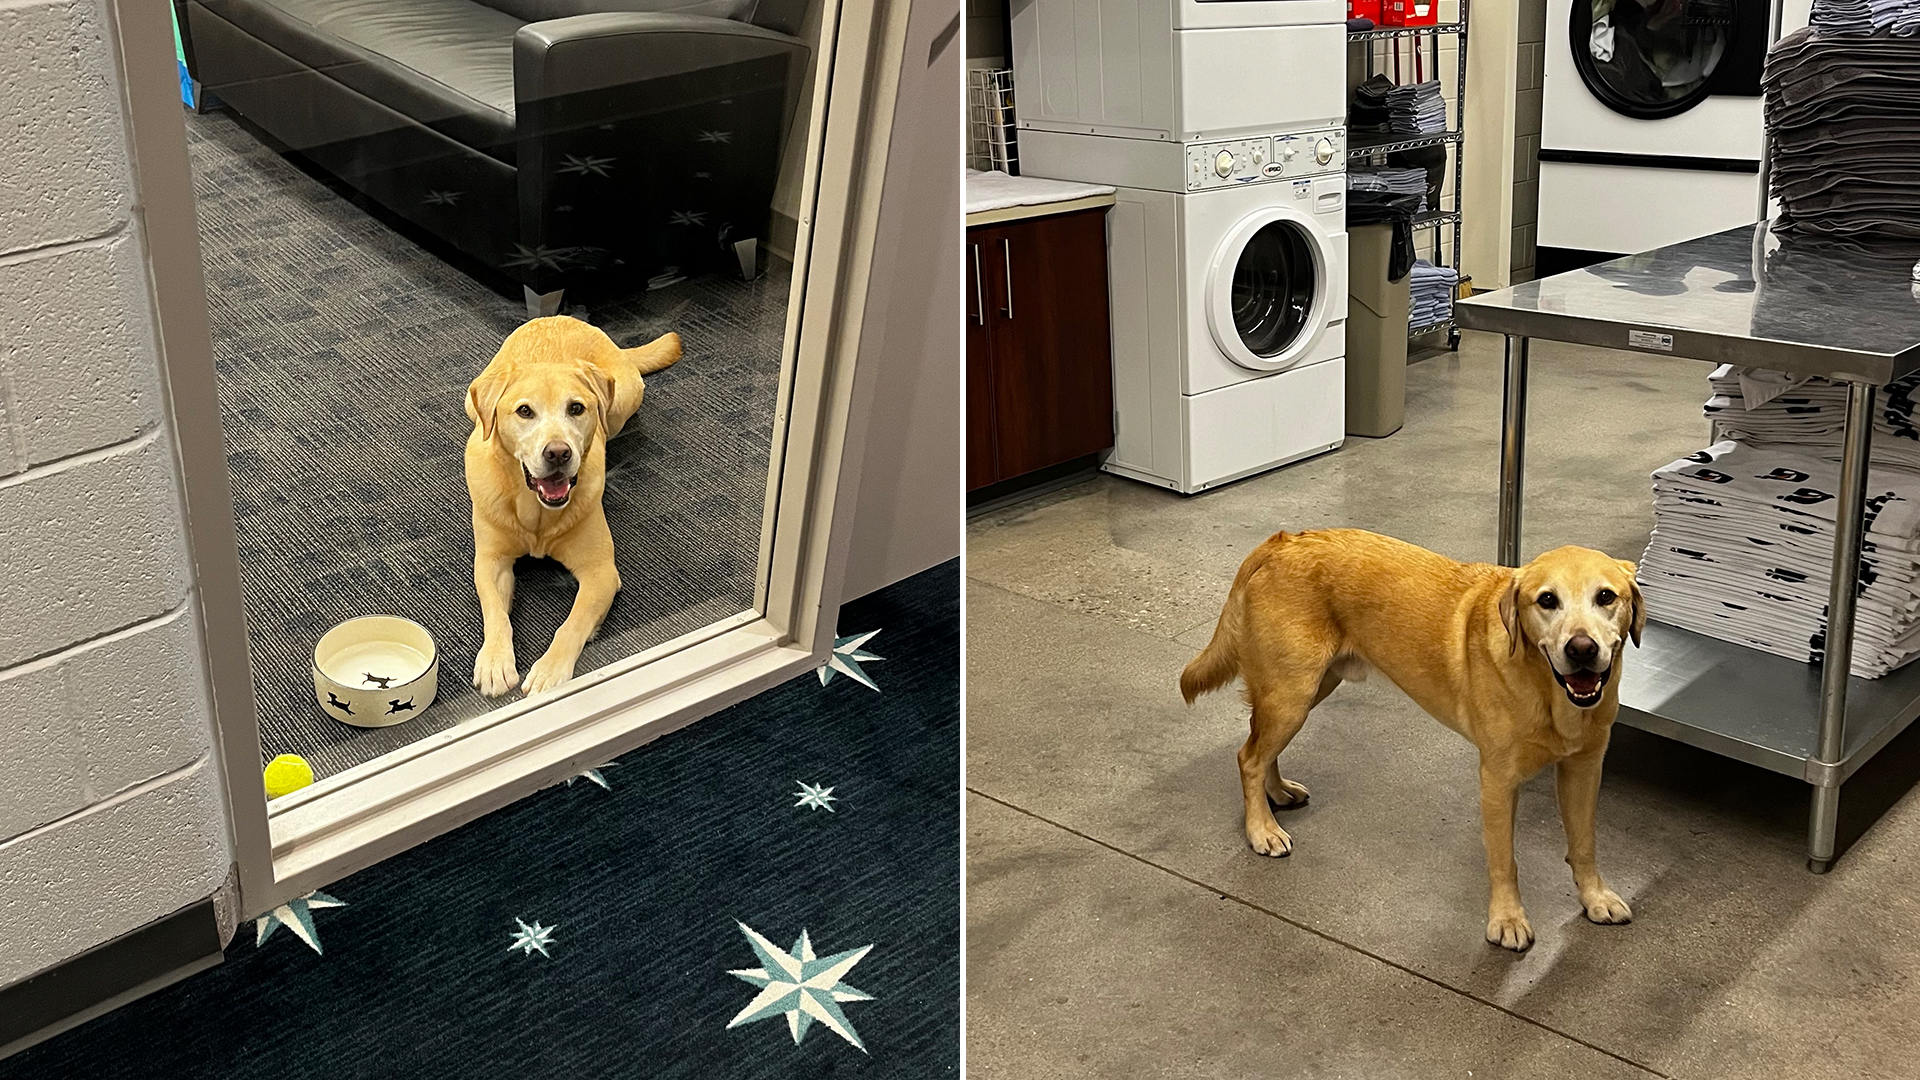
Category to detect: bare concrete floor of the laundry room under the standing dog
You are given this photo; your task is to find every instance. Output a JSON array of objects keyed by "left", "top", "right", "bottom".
[{"left": 966, "top": 334, "right": 1920, "bottom": 1080}]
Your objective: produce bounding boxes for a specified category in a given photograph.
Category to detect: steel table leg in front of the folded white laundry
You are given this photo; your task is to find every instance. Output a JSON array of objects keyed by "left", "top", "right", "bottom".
[{"left": 1807, "top": 382, "right": 1874, "bottom": 874}]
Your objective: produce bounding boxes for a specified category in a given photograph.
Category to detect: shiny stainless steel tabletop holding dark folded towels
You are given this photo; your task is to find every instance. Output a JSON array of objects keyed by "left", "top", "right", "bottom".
[{"left": 1453, "top": 225, "right": 1920, "bottom": 382}]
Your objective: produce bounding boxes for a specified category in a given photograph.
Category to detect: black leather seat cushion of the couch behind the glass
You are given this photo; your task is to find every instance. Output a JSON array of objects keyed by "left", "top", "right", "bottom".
[{"left": 202, "top": 0, "right": 524, "bottom": 161}]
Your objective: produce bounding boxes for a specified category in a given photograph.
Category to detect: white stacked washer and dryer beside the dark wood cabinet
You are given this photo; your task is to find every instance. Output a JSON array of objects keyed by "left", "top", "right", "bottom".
[{"left": 1012, "top": 0, "right": 1348, "bottom": 492}]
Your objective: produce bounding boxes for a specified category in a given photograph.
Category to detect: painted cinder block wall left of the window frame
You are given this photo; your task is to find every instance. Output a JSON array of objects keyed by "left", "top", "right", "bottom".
[{"left": 0, "top": 0, "right": 232, "bottom": 986}]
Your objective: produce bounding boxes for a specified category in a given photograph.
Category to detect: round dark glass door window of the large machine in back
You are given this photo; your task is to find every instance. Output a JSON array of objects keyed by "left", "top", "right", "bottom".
[{"left": 1569, "top": 0, "right": 1738, "bottom": 119}]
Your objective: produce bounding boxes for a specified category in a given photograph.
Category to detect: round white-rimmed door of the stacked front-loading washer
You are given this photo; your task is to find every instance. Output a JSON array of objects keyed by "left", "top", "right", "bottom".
[{"left": 1208, "top": 206, "right": 1331, "bottom": 371}]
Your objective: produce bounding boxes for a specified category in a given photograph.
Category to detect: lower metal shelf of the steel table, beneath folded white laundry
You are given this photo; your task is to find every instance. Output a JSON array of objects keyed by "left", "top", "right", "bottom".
[{"left": 1619, "top": 621, "right": 1920, "bottom": 778}]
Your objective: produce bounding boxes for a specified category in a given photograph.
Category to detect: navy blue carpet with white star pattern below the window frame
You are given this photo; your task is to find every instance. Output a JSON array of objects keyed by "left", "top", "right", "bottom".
[{"left": 0, "top": 561, "right": 960, "bottom": 1080}]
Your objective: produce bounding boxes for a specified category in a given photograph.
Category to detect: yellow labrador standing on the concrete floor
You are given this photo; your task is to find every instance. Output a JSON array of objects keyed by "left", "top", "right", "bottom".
[{"left": 1181, "top": 528, "right": 1647, "bottom": 949}]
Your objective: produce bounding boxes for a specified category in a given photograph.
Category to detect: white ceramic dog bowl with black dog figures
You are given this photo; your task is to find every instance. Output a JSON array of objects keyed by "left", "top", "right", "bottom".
[{"left": 313, "top": 615, "right": 440, "bottom": 728}]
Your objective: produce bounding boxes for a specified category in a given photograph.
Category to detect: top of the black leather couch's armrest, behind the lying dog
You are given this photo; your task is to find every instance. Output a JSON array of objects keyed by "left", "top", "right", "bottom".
[{"left": 513, "top": 12, "right": 808, "bottom": 104}]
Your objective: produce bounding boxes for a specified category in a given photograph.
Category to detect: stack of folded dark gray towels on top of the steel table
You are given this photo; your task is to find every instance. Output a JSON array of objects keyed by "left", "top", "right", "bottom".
[{"left": 1761, "top": 24, "right": 1920, "bottom": 238}]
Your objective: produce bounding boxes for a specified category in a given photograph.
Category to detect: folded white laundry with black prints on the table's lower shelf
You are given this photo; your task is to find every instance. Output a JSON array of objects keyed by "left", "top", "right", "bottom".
[{"left": 1638, "top": 434, "right": 1920, "bottom": 678}]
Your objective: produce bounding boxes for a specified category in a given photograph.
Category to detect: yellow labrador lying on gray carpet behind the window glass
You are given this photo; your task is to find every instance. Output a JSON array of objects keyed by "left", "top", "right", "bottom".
[{"left": 467, "top": 315, "right": 680, "bottom": 698}]
